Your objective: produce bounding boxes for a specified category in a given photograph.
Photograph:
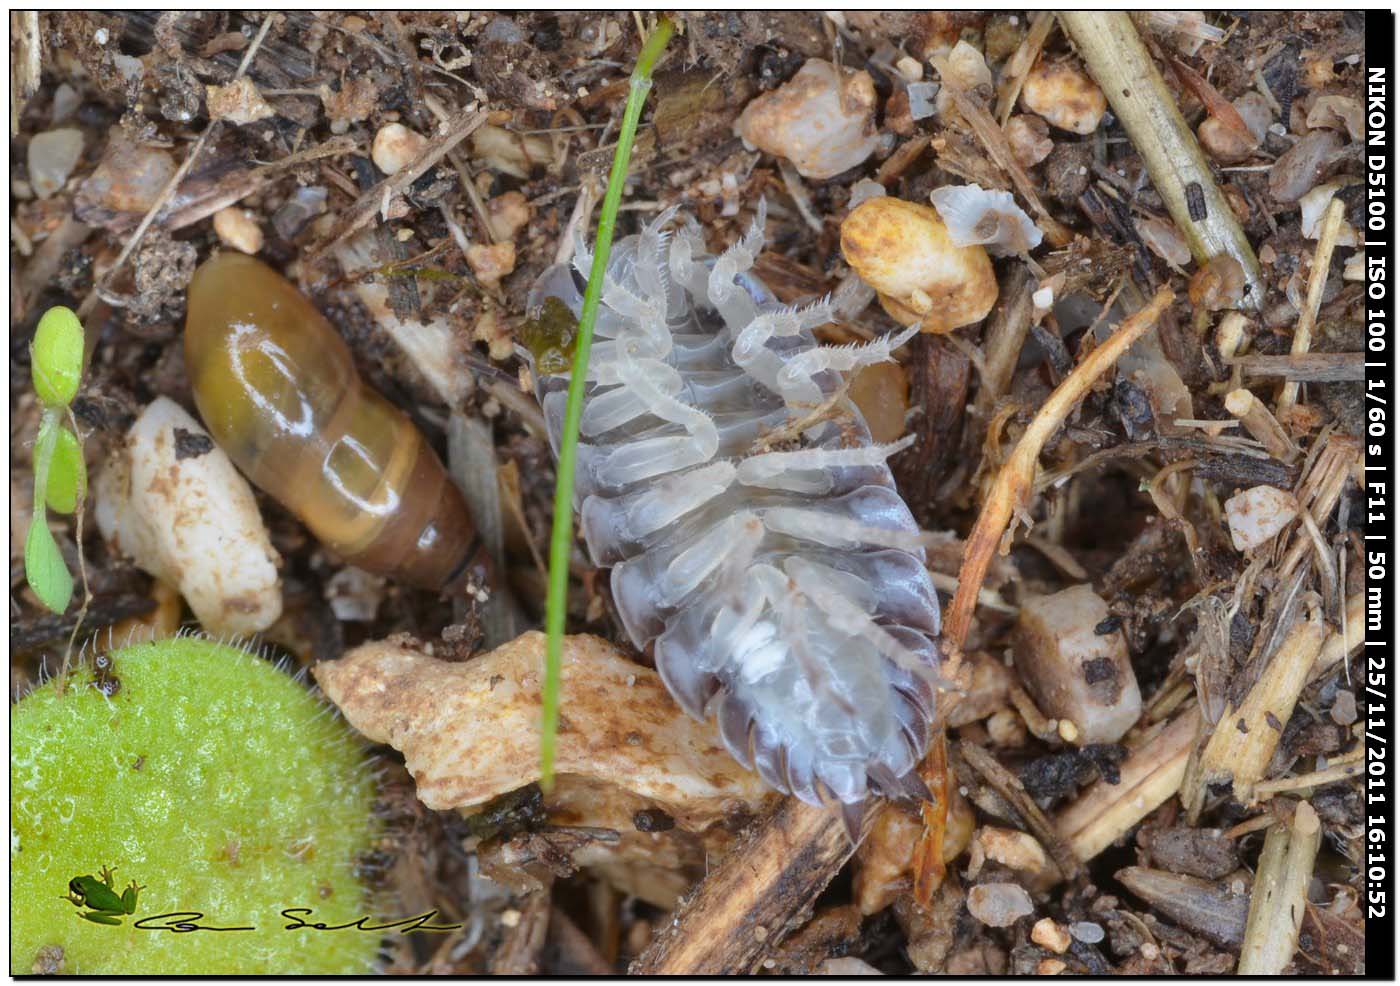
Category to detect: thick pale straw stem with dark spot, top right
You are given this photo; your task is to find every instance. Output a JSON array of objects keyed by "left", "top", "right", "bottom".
[{"left": 1058, "top": 10, "right": 1264, "bottom": 310}]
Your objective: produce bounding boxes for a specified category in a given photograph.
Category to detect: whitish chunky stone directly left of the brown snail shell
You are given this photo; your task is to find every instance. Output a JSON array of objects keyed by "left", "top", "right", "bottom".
[{"left": 95, "top": 398, "right": 281, "bottom": 634}]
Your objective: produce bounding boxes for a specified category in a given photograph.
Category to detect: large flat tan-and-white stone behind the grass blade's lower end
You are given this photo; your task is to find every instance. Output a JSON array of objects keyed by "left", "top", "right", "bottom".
[{"left": 315, "top": 632, "right": 766, "bottom": 831}]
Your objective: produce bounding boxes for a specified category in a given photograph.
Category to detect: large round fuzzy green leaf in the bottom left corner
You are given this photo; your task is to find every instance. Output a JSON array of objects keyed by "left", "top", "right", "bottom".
[{"left": 10, "top": 636, "right": 383, "bottom": 976}]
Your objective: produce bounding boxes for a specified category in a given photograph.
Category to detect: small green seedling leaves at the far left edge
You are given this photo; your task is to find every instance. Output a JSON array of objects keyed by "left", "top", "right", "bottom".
[{"left": 24, "top": 305, "right": 87, "bottom": 613}]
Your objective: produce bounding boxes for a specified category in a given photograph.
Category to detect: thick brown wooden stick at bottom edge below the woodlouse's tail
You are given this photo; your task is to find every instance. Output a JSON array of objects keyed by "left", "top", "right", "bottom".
[{"left": 630, "top": 798, "right": 855, "bottom": 976}]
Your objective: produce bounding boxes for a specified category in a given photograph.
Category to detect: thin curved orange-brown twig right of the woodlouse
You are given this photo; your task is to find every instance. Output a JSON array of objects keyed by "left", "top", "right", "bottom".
[{"left": 944, "top": 287, "right": 1175, "bottom": 647}]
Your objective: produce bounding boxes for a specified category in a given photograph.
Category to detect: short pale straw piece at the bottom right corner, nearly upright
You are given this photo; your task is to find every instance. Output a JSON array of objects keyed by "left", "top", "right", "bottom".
[{"left": 1236, "top": 801, "right": 1322, "bottom": 976}]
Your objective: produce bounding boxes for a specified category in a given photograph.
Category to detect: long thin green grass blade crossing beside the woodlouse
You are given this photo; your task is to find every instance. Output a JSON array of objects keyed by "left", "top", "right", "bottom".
[{"left": 539, "top": 17, "right": 673, "bottom": 790}]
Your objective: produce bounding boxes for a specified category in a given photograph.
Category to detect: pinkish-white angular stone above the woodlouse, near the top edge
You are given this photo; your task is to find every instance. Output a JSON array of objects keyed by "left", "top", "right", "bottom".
[{"left": 734, "top": 59, "right": 879, "bottom": 181}]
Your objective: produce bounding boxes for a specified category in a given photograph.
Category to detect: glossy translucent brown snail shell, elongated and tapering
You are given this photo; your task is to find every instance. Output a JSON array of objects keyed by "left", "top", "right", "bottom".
[{"left": 185, "top": 252, "right": 486, "bottom": 588}]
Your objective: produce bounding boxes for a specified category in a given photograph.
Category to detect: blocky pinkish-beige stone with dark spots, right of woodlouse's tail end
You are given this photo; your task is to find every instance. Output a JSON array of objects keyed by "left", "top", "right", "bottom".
[{"left": 1014, "top": 585, "right": 1142, "bottom": 745}]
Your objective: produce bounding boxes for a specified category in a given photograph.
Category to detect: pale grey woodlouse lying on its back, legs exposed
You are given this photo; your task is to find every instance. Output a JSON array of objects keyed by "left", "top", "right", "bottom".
[{"left": 529, "top": 210, "right": 938, "bottom": 814}]
